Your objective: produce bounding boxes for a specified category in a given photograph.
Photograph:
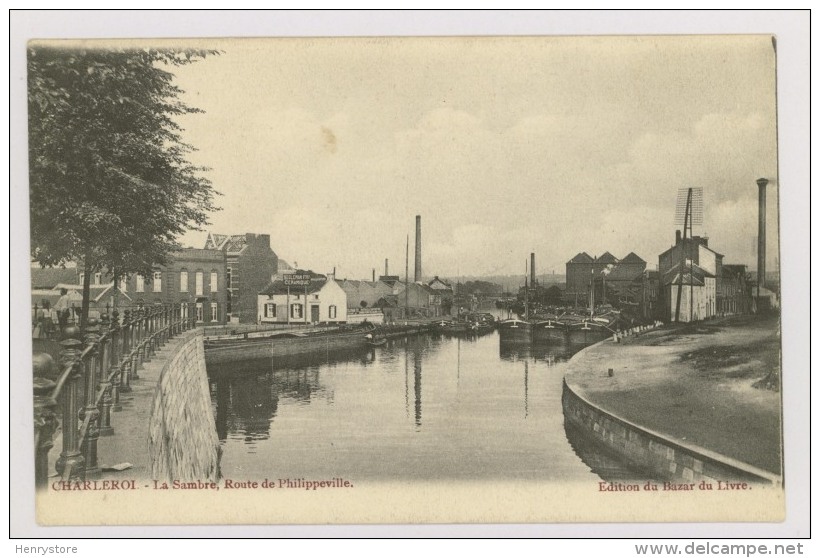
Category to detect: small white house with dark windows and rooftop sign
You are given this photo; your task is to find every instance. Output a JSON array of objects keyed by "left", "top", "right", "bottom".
[{"left": 257, "top": 276, "right": 347, "bottom": 324}]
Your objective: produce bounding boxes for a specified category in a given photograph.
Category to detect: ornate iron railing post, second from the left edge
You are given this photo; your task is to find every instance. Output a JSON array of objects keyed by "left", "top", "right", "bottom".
[{"left": 56, "top": 325, "right": 85, "bottom": 480}]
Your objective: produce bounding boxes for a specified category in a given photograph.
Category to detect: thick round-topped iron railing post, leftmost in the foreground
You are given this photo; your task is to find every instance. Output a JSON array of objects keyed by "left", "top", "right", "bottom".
[{"left": 33, "top": 353, "right": 57, "bottom": 489}]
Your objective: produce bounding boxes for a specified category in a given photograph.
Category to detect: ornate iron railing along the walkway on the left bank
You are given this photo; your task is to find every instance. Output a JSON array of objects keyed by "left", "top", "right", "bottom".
[{"left": 34, "top": 304, "right": 195, "bottom": 488}]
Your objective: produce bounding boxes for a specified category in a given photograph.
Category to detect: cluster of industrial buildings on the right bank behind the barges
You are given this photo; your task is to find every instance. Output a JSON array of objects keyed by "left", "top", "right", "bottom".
[{"left": 564, "top": 231, "right": 754, "bottom": 322}]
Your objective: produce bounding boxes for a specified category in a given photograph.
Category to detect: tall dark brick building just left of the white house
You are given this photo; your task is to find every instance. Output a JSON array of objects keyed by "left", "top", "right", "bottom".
[{"left": 205, "top": 233, "right": 279, "bottom": 324}]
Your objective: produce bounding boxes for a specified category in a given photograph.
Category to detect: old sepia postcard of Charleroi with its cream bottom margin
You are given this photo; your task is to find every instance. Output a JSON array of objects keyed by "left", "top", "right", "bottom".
[{"left": 16, "top": 29, "right": 804, "bottom": 526}]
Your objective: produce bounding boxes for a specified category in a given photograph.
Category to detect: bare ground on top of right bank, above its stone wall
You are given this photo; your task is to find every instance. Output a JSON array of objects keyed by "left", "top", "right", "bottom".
[{"left": 565, "top": 316, "right": 782, "bottom": 482}]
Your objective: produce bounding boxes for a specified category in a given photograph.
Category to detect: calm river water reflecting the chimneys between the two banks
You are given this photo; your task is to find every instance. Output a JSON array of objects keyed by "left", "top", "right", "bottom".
[{"left": 208, "top": 332, "right": 630, "bottom": 482}]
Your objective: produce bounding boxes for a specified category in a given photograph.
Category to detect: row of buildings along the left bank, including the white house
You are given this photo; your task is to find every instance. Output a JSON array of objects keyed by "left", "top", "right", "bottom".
[{"left": 31, "top": 233, "right": 453, "bottom": 325}]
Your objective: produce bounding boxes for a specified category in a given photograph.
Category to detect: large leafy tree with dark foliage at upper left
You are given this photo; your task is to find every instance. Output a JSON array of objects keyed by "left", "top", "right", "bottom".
[{"left": 28, "top": 44, "right": 218, "bottom": 332}]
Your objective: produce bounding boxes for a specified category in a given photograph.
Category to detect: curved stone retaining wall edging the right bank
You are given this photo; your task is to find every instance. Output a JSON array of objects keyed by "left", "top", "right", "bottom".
[{"left": 561, "top": 372, "right": 781, "bottom": 485}]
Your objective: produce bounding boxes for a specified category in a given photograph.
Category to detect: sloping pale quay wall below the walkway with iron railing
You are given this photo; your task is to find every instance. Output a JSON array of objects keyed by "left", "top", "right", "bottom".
[{"left": 148, "top": 328, "right": 219, "bottom": 481}]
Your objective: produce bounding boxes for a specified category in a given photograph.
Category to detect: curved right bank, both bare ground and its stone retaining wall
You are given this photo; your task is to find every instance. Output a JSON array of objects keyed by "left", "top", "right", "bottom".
[{"left": 564, "top": 317, "right": 782, "bottom": 484}]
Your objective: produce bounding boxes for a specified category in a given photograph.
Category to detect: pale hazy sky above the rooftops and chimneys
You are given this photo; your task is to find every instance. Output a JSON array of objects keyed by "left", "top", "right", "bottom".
[{"left": 165, "top": 35, "right": 778, "bottom": 278}]
